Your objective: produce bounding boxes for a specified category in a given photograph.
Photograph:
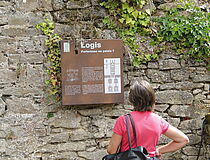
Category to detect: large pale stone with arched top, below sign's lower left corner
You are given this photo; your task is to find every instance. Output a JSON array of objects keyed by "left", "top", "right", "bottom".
[{"left": 50, "top": 110, "right": 81, "bottom": 128}]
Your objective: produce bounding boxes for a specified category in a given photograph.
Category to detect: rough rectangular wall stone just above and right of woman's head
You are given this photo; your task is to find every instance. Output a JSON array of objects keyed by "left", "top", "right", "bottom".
[{"left": 147, "top": 69, "right": 171, "bottom": 82}]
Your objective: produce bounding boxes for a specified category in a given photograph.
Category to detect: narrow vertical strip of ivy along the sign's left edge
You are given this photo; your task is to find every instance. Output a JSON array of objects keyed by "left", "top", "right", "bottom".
[{"left": 36, "top": 18, "right": 61, "bottom": 100}]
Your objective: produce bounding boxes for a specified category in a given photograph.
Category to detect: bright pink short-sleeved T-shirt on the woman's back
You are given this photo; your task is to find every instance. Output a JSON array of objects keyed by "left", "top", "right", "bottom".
[{"left": 113, "top": 111, "right": 169, "bottom": 157}]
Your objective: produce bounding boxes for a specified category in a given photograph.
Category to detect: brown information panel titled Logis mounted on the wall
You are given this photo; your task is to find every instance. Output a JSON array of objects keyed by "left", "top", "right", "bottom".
[{"left": 61, "top": 39, "right": 124, "bottom": 105}]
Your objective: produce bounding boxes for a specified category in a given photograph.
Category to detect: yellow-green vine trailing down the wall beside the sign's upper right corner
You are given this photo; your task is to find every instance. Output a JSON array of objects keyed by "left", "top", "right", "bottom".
[{"left": 100, "top": 0, "right": 158, "bottom": 66}]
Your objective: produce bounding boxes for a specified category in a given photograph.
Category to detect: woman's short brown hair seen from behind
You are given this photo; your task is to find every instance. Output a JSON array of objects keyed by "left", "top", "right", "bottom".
[{"left": 129, "top": 80, "right": 155, "bottom": 112}]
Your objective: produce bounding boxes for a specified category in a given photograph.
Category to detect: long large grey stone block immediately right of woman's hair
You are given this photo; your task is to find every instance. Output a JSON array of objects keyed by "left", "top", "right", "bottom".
[{"left": 156, "top": 90, "right": 193, "bottom": 104}]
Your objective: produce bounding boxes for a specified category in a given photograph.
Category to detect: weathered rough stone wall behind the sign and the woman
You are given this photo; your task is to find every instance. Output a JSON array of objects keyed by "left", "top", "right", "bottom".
[{"left": 0, "top": 0, "right": 210, "bottom": 160}]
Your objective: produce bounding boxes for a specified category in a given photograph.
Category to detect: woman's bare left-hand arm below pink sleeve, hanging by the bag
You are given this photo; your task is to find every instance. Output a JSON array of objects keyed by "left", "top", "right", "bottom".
[{"left": 107, "top": 133, "right": 122, "bottom": 154}]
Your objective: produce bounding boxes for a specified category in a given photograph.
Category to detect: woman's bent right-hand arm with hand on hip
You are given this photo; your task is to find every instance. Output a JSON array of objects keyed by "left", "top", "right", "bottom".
[{"left": 157, "top": 125, "right": 189, "bottom": 155}]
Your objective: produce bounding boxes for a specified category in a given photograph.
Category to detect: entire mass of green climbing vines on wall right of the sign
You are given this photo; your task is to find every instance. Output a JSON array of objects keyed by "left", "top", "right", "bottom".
[{"left": 101, "top": 0, "right": 210, "bottom": 68}]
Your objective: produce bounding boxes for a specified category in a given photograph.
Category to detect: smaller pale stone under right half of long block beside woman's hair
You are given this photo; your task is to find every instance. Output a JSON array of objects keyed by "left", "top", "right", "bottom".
[{"left": 168, "top": 105, "right": 193, "bottom": 117}]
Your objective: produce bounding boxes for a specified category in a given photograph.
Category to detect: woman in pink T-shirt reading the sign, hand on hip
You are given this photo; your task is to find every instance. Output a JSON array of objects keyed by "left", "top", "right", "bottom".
[{"left": 107, "top": 81, "right": 189, "bottom": 157}]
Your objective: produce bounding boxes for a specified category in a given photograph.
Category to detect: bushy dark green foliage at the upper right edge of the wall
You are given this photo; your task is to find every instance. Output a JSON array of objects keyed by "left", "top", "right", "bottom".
[{"left": 155, "top": 5, "right": 210, "bottom": 68}]
